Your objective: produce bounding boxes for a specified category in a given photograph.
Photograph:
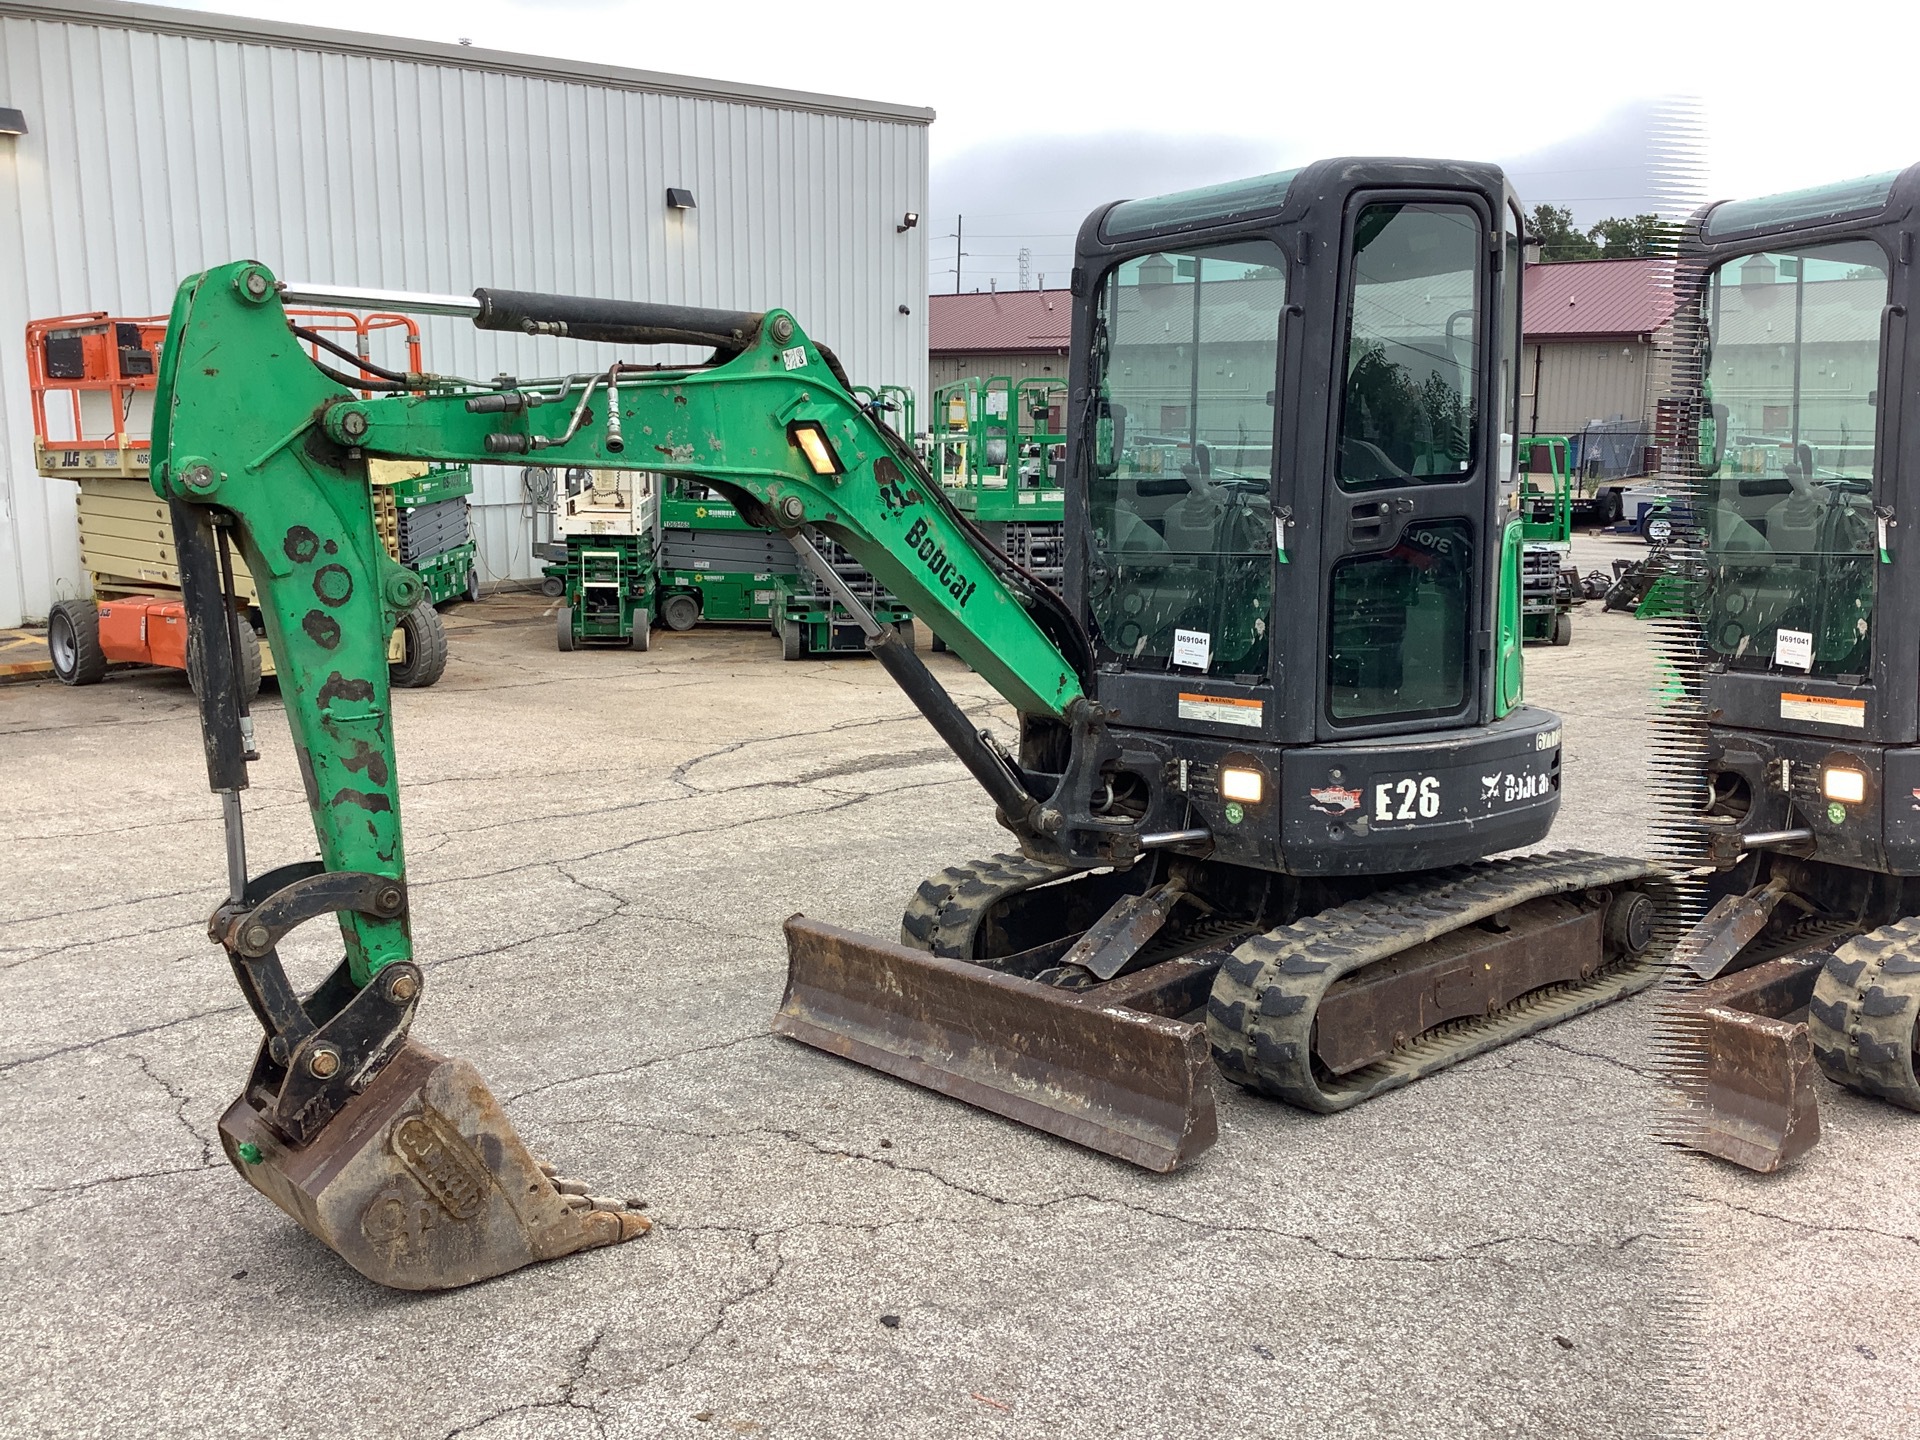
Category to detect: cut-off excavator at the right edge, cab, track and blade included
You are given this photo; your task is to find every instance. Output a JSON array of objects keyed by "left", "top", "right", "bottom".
[{"left": 1670, "top": 165, "right": 1920, "bottom": 1169}]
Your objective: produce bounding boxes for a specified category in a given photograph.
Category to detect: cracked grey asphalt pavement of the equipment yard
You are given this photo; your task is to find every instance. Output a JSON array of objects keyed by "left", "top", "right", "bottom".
[{"left": 0, "top": 568, "right": 1920, "bottom": 1440}]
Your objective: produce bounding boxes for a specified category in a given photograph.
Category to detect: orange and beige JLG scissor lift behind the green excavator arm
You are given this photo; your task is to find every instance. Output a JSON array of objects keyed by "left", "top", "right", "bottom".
[{"left": 27, "top": 309, "right": 445, "bottom": 695}]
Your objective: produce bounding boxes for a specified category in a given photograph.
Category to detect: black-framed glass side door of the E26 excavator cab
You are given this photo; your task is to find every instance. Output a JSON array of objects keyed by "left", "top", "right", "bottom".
[{"left": 1317, "top": 190, "right": 1501, "bottom": 739}]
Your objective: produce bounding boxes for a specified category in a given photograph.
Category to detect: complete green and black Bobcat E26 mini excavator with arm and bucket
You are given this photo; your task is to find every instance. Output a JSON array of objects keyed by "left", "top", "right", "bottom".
[{"left": 154, "top": 159, "right": 1657, "bottom": 1288}]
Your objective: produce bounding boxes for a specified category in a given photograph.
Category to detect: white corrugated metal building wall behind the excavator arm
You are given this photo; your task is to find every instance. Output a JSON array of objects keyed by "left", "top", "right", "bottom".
[{"left": 0, "top": 0, "right": 933, "bottom": 626}]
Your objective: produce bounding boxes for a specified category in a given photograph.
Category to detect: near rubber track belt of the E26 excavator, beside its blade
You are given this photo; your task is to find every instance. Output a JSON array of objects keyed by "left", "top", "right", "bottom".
[{"left": 1208, "top": 851, "right": 1661, "bottom": 1114}]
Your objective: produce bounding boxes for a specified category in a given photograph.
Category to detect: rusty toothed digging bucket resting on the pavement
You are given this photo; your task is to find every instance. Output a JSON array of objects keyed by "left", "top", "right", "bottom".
[{"left": 221, "top": 1041, "right": 651, "bottom": 1290}]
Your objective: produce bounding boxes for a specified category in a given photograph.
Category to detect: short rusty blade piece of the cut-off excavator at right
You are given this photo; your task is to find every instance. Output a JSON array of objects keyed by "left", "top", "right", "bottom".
[{"left": 1686, "top": 956, "right": 1824, "bottom": 1173}]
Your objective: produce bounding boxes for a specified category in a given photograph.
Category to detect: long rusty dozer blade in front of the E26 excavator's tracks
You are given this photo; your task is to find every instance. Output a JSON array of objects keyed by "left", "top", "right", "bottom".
[{"left": 774, "top": 916, "right": 1217, "bottom": 1171}]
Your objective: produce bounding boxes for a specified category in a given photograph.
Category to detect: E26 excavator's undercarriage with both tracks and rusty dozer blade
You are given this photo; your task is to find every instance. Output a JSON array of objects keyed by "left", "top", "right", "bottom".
[{"left": 774, "top": 852, "right": 1661, "bottom": 1171}]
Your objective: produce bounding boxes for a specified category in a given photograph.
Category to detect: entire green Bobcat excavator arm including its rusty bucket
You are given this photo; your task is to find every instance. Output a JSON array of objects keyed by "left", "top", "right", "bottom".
[{"left": 152, "top": 263, "right": 1152, "bottom": 1288}]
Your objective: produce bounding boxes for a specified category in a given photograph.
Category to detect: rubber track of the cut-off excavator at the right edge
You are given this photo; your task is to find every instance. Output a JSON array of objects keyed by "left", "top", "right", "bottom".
[{"left": 1807, "top": 916, "right": 1920, "bottom": 1110}]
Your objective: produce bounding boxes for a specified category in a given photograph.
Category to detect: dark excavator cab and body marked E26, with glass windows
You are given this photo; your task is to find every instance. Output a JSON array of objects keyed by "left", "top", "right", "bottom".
[{"left": 1023, "top": 161, "right": 1559, "bottom": 876}]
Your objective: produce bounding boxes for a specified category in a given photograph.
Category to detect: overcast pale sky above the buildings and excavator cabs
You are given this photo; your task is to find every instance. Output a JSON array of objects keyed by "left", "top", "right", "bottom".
[{"left": 192, "top": 0, "right": 1920, "bottom": 290}]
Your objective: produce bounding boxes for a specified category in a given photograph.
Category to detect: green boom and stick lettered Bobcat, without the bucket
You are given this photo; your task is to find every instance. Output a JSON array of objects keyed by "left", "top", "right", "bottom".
[{"left": 152, "top": 263, "right": 1096, "bottom": 985}]
